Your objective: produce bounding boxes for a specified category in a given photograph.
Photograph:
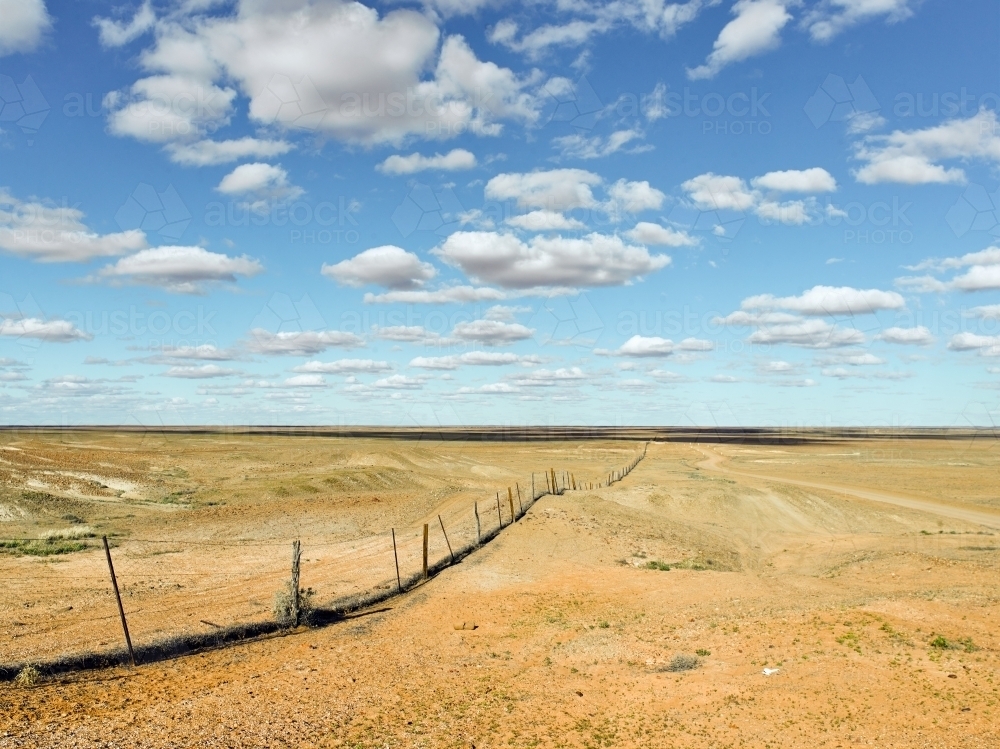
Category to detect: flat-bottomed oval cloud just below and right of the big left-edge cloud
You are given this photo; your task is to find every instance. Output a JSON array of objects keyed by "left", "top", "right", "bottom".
[{"left": 97, "top": 246, "right": 264, "bottom": 294}]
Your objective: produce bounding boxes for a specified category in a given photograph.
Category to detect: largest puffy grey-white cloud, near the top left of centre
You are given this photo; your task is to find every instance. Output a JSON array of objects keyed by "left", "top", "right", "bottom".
[{"left": 109, "top": 0, "right": 540, "bottom": 149}]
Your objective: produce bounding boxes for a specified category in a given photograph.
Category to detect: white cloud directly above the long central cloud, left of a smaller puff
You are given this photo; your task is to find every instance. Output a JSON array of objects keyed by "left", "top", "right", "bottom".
[{"left": 485, "top": 169, "right": 603, "bottom": 211}]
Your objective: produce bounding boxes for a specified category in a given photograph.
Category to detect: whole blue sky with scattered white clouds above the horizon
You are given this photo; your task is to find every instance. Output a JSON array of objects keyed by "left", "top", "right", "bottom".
[{"left": 0, "top": 0, "right": 1000, "bottom": 427}]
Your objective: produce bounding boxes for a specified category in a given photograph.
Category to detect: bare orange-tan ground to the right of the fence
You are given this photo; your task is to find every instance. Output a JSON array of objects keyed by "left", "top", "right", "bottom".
[{"left": 0, "top": 436, "right": 1000, "bottom": 749}]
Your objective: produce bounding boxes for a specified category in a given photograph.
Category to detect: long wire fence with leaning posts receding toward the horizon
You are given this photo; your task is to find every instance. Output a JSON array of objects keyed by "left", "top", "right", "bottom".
[{"left": 0, "top": 448, "right": 645, "bottom": 679}]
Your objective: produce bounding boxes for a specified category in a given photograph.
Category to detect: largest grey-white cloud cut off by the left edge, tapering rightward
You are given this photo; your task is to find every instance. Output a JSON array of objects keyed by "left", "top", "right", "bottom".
[{"left": 0, "top": 189, "right": 146, "bottom": 263}]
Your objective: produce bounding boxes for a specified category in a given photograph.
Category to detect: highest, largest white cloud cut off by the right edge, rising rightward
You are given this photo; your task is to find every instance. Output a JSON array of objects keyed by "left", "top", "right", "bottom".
[{"left": 855, "top": 109, "right": 1000, "bottom": 185}]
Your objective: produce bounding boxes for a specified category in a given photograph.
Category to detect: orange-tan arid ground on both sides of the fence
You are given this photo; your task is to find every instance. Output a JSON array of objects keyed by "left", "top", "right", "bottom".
[{"left": 0, "top": 433, "right": 1000, "bottom": 749}]
